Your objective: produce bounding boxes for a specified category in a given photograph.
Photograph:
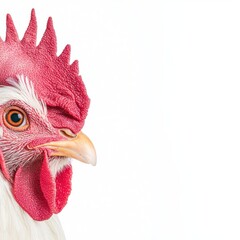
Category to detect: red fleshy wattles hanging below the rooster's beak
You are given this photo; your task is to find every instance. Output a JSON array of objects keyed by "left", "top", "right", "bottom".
[{"left": 13, "top": 151, "right": 72, "bottom": 221}]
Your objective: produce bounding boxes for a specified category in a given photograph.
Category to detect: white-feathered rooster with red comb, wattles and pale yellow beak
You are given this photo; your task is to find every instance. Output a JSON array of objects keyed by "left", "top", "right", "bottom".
[{"left": 0, "top": 10, "right": 96, "bottom": 240}]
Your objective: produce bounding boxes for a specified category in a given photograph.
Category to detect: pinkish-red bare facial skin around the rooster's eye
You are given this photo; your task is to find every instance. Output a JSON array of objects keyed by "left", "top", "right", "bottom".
[{"left": 0, "top": 101, "right": 69, "bottom": 178}]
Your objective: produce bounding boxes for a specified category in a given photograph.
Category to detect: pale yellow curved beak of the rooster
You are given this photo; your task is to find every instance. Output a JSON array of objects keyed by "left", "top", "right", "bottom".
[{"left": 38, "top": 132, "right": 97, "bottom": 166}]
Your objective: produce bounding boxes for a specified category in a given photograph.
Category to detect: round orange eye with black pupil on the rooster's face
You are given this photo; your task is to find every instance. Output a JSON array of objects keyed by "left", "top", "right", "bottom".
[{"left": 3, "top": 106, "right": 29, "bottom": 131}]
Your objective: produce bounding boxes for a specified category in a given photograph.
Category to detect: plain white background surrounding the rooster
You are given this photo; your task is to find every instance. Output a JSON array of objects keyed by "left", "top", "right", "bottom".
[{"left": 0, "top": 0, "right": 240, "bottom": 240}]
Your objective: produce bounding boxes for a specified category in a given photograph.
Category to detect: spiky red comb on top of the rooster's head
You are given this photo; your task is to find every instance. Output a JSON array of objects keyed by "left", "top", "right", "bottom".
[{"left": 0, "top": 9, "right": 89, "bottom": 132}]
